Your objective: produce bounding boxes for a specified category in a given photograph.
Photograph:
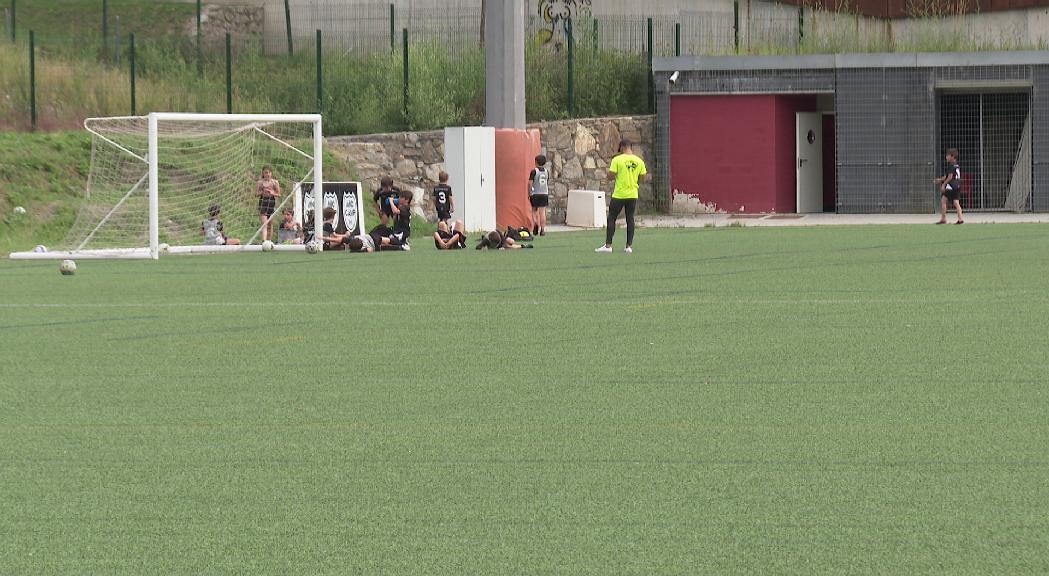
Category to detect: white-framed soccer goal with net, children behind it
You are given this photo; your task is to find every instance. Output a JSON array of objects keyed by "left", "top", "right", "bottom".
[{"left": 12, "top": 113, "right": 324, "bottom": 259}]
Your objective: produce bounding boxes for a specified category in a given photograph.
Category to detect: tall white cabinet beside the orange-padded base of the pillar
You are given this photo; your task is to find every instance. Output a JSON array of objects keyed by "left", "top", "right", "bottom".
[{"left": 445, "top": 126, "right": 495, "bottom": 231}]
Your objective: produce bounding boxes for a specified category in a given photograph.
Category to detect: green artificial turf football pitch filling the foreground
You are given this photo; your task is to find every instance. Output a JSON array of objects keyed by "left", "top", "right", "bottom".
[{"left": 0, "top": 225, "right": 1049, "bottom": 575}]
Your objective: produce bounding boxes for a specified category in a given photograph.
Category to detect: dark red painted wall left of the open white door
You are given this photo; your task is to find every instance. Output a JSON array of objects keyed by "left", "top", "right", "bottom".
[{"left": 670, "top": 94, "right": 816, "bottom": 213}]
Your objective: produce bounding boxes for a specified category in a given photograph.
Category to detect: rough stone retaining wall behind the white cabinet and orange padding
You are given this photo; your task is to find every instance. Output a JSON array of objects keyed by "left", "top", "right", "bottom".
[{"left": 327, "top": 115, "right": 655, "bottom": 222}]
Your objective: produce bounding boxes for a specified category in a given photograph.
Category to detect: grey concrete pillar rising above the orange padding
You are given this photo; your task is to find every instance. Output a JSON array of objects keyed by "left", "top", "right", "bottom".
[{"left": 485, "top": 0, "right": 525, "bottom": 129}]
